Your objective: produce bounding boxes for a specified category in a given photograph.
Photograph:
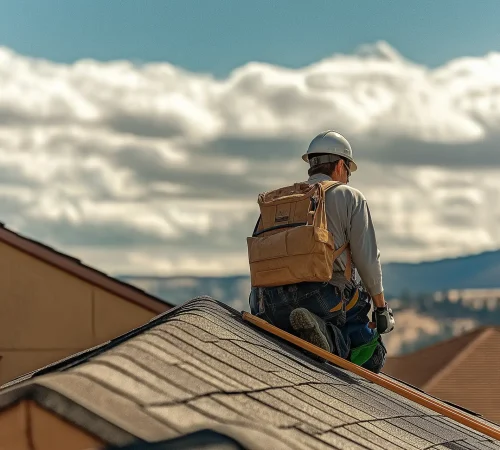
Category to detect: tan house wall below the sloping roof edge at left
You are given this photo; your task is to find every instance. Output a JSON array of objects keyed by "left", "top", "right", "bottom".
[{"left": 0, "top": 242, "right": 157, "bottom": 384}]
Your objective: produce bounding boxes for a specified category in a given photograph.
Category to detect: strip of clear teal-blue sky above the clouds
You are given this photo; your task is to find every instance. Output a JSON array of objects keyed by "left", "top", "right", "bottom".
[{"left": 0, "top": 0, "right": 500, "bottom": 77}]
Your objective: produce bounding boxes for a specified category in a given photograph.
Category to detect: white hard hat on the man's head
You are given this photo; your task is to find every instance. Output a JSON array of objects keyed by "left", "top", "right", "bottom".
[{"left": 302, "top": 130, "right": 358, "bottom": 172}]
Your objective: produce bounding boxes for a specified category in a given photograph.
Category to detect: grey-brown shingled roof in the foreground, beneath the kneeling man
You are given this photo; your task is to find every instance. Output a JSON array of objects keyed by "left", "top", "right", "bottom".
[{"left": 0, "top": 297, "right": 500, "bottom": 450}]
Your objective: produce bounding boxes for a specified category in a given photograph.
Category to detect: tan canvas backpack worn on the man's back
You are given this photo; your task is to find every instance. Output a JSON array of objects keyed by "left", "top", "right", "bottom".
[{"left": 247, "top": 181, "right": 351, "bottom": 287}]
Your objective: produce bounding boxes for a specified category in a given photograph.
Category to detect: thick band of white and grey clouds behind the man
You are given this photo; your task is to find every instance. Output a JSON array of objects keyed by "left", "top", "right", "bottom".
[{"left": 0, "top": 43, "right": 500, "bottom": 274}]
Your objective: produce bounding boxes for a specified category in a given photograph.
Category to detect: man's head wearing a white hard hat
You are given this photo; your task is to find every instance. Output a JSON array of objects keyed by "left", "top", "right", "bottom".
[{"left": 302, "top": 130, "right": 358, "bottom": 183}]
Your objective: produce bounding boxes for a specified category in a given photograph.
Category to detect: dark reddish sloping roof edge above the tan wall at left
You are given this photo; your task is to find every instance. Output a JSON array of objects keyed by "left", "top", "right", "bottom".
[{"left": 0, "top": 222, "right": 173, "bottom": 313}]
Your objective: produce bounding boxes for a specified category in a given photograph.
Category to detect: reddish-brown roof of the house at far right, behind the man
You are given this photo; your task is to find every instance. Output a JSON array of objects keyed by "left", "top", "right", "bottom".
[{"left": 384, "top": 327, "right": 500, "bottom": 423}]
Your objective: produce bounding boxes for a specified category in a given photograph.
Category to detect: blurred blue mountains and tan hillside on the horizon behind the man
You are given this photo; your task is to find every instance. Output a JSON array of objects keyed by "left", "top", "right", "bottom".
[{"left": 118, "top": 251, "right": 500, "bottom": 354}]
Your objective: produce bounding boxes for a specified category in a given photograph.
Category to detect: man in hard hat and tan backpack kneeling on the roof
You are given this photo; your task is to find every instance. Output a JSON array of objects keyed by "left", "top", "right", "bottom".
[{"left": 247, "top": 130, "right": 395, "bottom": 373}]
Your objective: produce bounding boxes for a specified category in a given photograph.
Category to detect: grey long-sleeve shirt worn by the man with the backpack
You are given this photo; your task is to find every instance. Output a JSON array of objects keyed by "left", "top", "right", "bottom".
[{"left": 307, "top": 174, "right": 384, "bottom": 296}]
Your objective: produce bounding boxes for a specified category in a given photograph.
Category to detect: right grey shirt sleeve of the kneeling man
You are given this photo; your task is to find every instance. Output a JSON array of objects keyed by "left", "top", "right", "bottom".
[{"left": 350, "top": 193, "right": 384, "bottom": 296}]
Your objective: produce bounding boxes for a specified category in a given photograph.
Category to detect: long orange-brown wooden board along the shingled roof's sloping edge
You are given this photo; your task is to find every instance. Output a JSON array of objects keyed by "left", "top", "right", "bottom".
[{"left": 242, "top": 311, "right": 500, "bottom": 440}]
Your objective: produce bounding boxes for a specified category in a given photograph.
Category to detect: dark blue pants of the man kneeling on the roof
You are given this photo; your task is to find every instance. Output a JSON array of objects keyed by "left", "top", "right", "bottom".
[{"left": 249, "top": 282, "right": 386, "bottom": 373}]
